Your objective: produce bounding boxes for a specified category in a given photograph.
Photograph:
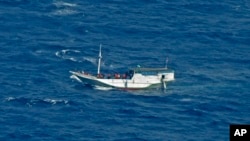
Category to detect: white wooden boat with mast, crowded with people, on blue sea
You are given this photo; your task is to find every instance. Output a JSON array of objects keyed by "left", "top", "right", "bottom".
[{"left": 70, "top": 45, "right": 174, "bottom": 90}]
